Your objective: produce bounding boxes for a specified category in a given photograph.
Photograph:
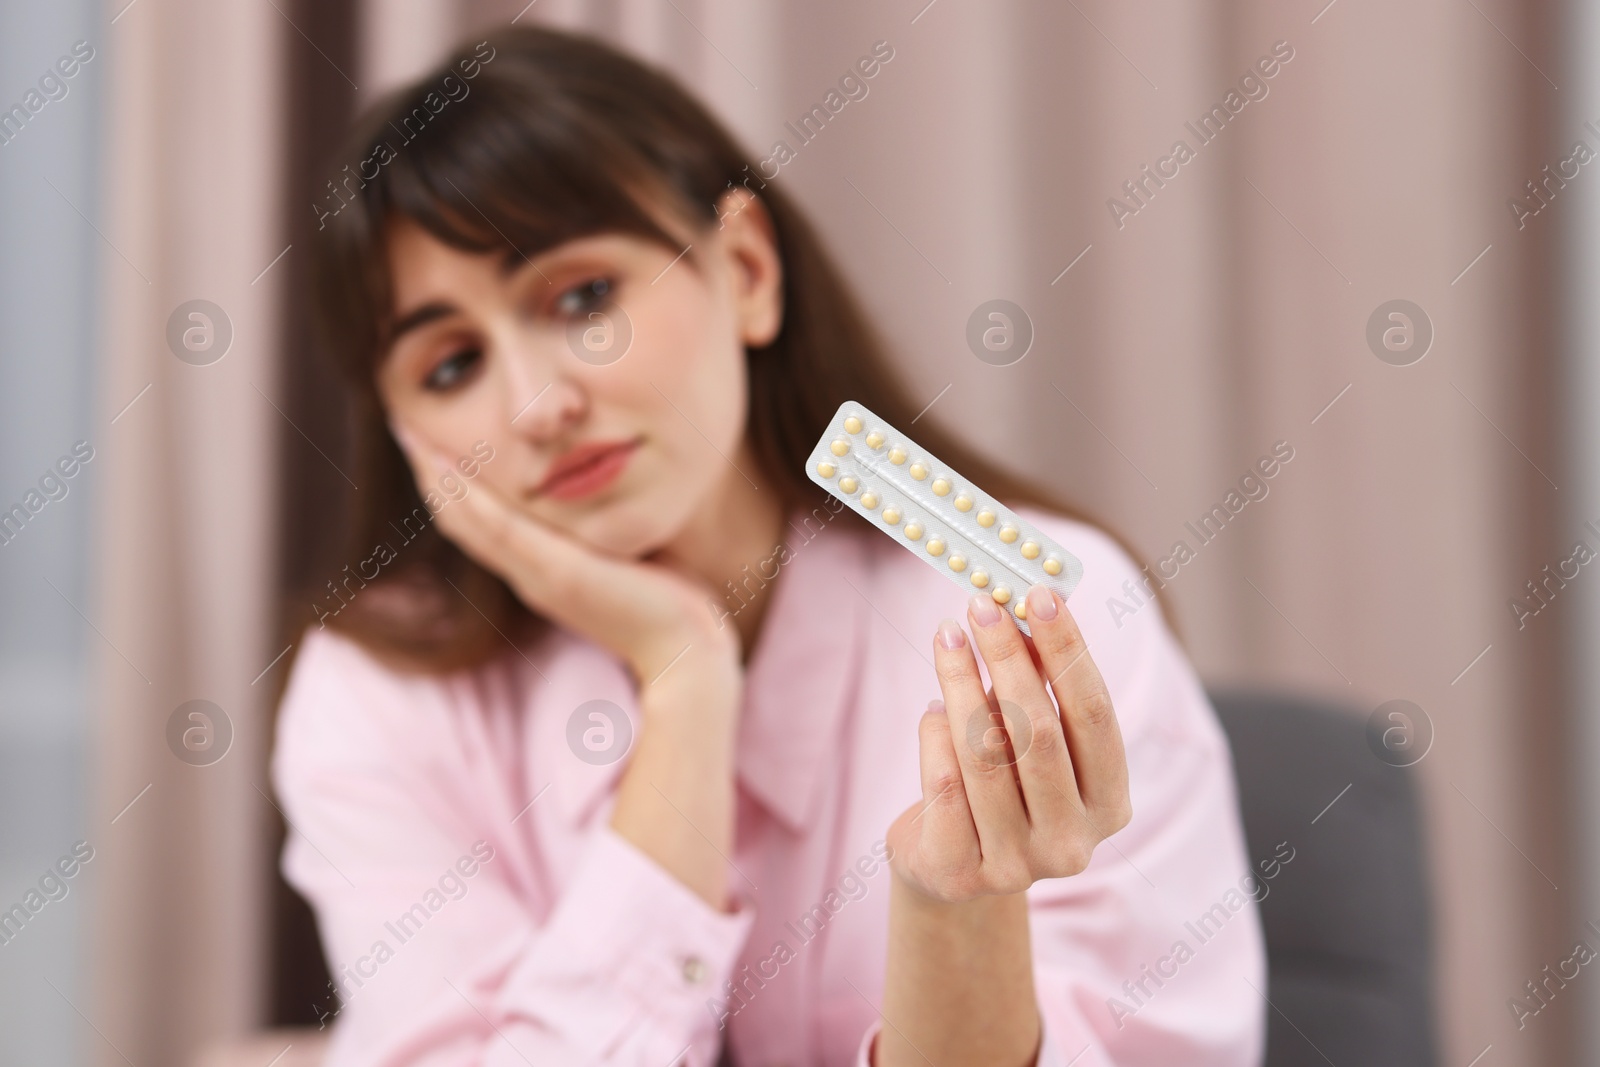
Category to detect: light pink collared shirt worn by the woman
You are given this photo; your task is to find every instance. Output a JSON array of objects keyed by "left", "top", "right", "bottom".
[{"left": 272, "top": 509, "right": 1275, "bottom": 1067}]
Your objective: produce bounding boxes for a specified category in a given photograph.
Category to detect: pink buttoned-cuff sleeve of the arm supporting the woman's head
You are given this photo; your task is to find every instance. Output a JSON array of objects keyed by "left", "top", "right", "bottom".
[{"left": 272, "top": 632, "right": 754, "bottom": 1067}]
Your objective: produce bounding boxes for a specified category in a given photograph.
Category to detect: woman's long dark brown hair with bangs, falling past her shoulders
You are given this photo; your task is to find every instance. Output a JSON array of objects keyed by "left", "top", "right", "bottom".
[{"left": 312, "top": 27, "right": 1139, "bottom": 670}]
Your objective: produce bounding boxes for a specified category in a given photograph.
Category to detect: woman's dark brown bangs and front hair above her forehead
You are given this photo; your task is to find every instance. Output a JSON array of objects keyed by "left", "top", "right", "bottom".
[{"left": 315, "top": 30, "right": 736, "bottom": 382}]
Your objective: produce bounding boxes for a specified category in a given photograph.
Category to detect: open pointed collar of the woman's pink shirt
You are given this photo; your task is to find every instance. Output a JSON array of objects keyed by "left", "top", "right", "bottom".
[{"left": 536, "top": 507, "right": 870, "bottom": 832}]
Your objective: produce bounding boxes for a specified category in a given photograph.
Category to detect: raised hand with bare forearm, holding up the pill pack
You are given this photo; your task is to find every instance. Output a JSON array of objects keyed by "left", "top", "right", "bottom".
[{"left": 874, "top": 585, "right": 1130, "bottom": 1067}]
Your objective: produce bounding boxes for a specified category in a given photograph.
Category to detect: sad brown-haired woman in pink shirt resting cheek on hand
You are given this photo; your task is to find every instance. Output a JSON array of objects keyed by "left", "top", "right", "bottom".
[{"left": 274, "top": 20, "right": 1266, "bottom": 1067}]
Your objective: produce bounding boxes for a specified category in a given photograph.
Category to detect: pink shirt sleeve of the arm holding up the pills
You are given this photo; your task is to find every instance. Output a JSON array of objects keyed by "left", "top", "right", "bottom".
[{"left": 856, "top": 517, "right": 1267, "bottom": 1067}]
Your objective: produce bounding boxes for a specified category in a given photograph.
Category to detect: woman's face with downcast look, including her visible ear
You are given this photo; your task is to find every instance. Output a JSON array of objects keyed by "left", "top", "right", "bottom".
[{"left": 378, "top": 190, "right": 782, "bottom": 557}]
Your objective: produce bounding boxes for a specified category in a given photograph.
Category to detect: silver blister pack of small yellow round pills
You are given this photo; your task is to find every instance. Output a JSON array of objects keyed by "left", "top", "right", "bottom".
[{"left": 806, "top": 400, "right": 1083, "bottom": 633}]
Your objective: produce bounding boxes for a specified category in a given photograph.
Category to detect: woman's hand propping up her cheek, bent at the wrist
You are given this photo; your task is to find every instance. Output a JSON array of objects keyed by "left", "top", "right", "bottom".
[{"left": 392, "top": 424, "right": 739, "bottom": 686}]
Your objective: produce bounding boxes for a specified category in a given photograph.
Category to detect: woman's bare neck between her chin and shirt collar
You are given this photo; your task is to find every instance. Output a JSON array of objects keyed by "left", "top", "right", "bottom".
[{"left": 656, "top": 442, "right": 786, "bottom": 659}]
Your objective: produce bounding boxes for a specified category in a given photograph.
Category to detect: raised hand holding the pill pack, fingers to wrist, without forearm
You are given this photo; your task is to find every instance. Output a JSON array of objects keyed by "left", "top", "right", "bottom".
[{"left": 888, "top": 585, "right": 1131, "bottom": 902}]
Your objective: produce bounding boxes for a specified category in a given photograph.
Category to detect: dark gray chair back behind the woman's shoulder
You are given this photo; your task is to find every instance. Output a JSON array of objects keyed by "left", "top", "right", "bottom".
[{"left": 1211, "top": 693, "right": 1438, "bottom": 1067}]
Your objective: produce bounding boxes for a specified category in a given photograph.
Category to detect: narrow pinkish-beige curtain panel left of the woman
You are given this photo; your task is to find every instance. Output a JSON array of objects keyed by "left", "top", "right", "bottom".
[{"left": 90, "top": 0, "right": 294, "bottom": 1065}]
